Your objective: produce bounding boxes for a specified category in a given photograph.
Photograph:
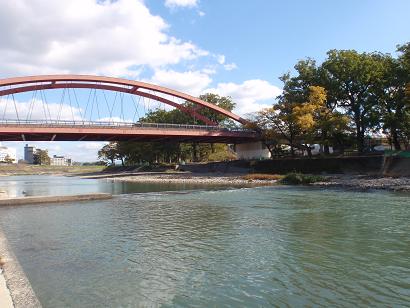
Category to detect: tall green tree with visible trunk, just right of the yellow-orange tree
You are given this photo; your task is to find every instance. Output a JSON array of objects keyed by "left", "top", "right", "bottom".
[{"left": 322, "top": 50, "right": 383, "bottom": 152}]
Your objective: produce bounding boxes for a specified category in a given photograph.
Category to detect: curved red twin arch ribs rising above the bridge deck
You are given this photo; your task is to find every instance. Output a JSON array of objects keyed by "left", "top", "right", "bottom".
[{"left": 0, "top": 75, "right": 247, "bottom": 126}]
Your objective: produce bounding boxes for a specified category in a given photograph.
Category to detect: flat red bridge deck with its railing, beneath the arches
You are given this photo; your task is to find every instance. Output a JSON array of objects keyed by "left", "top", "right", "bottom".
[{"left": 0, "top": 120, "right": 258, "bottom": 144}]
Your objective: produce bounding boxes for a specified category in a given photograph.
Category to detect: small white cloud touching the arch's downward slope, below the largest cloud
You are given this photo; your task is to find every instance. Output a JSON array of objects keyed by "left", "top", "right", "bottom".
[{"left": 150, "top": 70, "right": 212, "bottom": 96}]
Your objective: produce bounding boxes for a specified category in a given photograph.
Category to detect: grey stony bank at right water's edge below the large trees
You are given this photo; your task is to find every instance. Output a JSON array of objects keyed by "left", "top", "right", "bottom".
[{"left": 313, "top": 175, "right": 410, "bottom": 192}]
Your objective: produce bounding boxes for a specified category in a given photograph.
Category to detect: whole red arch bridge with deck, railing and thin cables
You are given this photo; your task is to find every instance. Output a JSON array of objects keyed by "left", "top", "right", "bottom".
[{"left": 0, "top": 75, "right": 258, "bottom": 143}]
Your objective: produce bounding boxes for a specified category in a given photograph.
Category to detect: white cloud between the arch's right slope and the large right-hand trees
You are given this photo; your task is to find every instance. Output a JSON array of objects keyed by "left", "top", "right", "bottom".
[{"left": 204, "top": 79, "right": 282, "bottom": 115}]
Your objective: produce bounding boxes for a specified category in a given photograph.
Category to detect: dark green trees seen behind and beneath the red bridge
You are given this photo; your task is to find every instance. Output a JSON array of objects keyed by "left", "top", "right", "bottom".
[{"left": 98, "top": 94, "right": 235, "bottom": 166}]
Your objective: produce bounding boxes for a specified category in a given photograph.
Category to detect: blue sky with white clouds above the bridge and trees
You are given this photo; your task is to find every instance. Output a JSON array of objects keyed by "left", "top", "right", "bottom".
[{"left": 0, "top": 0, "right": 410, "bottom": 161}]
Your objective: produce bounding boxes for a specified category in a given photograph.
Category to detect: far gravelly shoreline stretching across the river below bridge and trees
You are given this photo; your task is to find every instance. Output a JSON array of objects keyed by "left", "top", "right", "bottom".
[{"left": 0, "top": 165, "right": 410, "bottom": 192}]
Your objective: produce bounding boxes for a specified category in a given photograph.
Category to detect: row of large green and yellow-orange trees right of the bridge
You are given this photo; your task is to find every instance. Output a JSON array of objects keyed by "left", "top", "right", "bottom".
[{"left": 250, "top": 43, "right": 410, "bottom": 156}]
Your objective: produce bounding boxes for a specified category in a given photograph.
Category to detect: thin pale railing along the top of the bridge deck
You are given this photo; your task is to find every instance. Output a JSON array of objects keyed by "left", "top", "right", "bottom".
[{"left": 0, "top": 119, "right": 254, "bottom": 133}]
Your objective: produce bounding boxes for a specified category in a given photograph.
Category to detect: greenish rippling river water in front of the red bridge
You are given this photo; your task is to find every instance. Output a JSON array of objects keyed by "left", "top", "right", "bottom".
[{"left": 0, "top": 177, "right": 410, "bottom": 307}]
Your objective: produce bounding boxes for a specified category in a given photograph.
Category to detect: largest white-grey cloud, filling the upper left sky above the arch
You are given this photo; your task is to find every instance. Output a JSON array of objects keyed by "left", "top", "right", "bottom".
[{"left": 0, "top": 0, "right": 208, "bottom": 77}]
